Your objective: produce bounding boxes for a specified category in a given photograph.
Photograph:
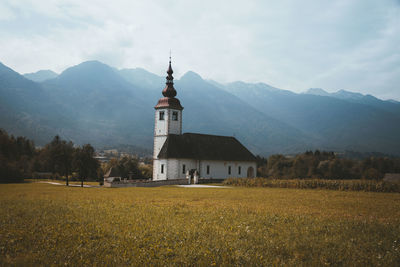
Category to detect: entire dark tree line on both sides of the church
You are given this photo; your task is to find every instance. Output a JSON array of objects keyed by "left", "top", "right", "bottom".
[{"left": 0, "top": 129, "right": 400, "bottom": 185}]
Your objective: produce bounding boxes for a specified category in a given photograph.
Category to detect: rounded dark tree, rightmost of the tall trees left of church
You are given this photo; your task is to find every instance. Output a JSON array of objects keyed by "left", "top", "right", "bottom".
[{"left": 73, "top": 144, "right": 100, "bottom": 187}]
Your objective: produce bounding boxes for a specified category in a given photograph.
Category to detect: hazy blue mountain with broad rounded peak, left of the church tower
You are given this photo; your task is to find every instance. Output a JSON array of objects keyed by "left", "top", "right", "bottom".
[{"left": 42, "top": 61, "right": 154, "bottom": 147}]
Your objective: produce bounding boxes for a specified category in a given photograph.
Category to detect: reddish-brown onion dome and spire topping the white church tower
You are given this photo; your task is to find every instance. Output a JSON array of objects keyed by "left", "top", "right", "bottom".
[{"left": 155, "top": 57, "right": 183, "bottom": 110}]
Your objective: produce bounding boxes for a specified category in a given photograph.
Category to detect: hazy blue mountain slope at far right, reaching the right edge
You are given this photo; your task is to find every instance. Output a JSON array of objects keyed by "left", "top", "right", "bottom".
[{"left": 225, "top": 82, "right": 400, "bottom": 153}]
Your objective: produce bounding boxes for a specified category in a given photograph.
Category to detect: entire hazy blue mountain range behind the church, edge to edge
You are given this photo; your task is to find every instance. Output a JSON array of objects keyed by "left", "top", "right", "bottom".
[{"left": 0, "top": 61, "right": 400, "bottom": 156}]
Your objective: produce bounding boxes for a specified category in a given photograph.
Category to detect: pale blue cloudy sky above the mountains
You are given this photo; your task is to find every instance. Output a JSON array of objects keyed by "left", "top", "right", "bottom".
[{"left": 0, "top": 0, "right": 400, "bottom": 100}]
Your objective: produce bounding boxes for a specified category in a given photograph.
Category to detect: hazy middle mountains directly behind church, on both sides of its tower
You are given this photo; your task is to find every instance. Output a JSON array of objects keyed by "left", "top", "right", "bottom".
[{"left": 42, "top": 61, "right": 310, "bottom": 153}]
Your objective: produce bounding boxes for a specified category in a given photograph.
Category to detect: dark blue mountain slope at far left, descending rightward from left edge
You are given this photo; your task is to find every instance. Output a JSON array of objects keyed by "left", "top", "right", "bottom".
[{"left": 0, "top": 63, "right": 73, "bottom": 144}]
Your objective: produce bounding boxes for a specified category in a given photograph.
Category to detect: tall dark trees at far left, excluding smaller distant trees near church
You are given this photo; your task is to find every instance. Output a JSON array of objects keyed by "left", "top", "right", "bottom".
[{"left": 0, "top": 129, "right": 100, "bottom": 186}]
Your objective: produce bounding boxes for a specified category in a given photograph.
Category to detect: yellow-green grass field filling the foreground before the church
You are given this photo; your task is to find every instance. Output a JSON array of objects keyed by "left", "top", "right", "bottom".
[{"left": 0, "top": 183, "right": 400, "bottom": 266}]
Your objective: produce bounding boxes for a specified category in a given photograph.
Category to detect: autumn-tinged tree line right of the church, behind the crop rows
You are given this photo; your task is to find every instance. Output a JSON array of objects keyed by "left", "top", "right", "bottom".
[{"left": 257, "top": 150, "right": 400, "bottom": 180}]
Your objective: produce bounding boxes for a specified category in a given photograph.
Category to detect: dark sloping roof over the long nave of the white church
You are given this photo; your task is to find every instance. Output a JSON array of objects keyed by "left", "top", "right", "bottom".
[{"left": 158, "top": 133, "right": 256, "bottom": 161}]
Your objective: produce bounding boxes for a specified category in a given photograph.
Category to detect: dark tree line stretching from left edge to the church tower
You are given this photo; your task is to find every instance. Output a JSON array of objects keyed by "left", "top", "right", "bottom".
[{"left": 0, "top": 129, "right": 152, "bottom": 186}]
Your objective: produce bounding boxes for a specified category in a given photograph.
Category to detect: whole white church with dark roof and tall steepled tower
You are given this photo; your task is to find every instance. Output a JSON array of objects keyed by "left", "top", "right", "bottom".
[{"left": 153, "top": 59, "right": 256, "bottom": 183}]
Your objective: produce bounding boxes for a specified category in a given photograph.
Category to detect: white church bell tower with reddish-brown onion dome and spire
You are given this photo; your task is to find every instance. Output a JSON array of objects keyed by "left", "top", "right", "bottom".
[{"left": 153, "top": 56, "right": 183, "bottom": 180}]
